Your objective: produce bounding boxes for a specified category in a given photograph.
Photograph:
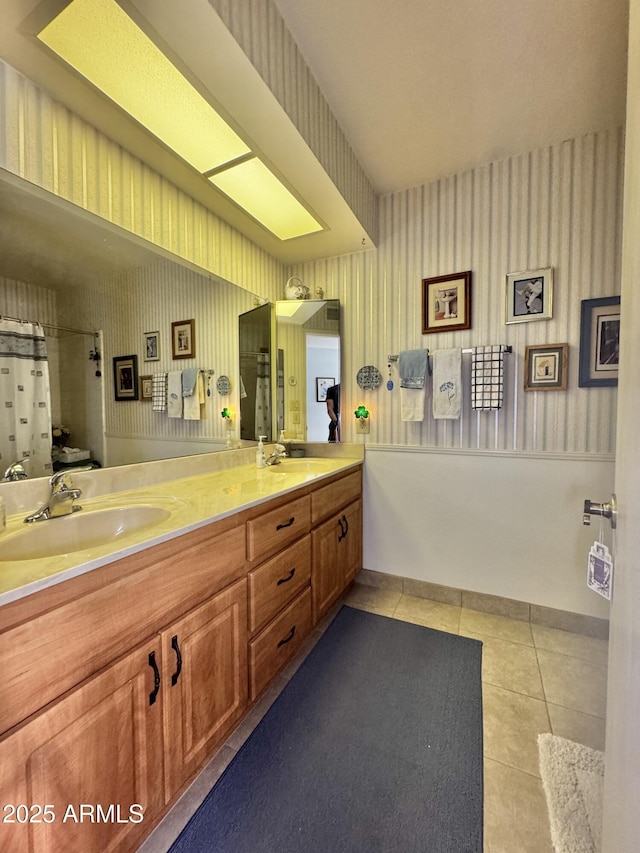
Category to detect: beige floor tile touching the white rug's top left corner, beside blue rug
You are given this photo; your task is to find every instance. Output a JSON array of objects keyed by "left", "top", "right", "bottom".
[{"left": 482, "top": 684, "right": 551, "bottom": 776}]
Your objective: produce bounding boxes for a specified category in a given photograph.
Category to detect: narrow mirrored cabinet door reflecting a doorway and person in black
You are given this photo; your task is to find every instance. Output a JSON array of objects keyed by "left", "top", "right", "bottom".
[{"left": 275, "top": 299, "right": 341, "bottom": 441}]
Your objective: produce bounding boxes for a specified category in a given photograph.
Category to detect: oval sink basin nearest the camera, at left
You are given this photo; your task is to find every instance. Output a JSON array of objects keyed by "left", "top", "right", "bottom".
[{"left": 0, "top": 504, "right": 171, "bottom": 561}]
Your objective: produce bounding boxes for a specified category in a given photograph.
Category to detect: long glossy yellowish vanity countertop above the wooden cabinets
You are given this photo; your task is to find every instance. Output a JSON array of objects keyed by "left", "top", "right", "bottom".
[{"left": 0, "top": 456, "right": 363, "bottom": 606}]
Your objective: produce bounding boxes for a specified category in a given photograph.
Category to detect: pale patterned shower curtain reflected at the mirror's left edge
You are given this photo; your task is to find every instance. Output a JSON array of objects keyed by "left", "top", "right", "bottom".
[{"left": 0, "top": 319, "right": 52, "bottom": 477}]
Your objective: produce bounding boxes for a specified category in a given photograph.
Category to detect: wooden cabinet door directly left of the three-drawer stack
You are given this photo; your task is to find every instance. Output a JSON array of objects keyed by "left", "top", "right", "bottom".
[{"left": 162, "top": 579, "right": 248, "bottom": 802}]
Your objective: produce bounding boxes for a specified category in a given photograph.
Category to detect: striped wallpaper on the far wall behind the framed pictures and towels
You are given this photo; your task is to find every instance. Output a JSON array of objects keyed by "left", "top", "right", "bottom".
[{"left": 291, "top": 128, "right": 623, "bottom": 455}]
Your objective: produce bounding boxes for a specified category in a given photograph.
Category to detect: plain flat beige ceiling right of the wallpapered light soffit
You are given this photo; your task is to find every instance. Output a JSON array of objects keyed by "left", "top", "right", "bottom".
[{"left": 274, "top": 0, "right": 628, "bottom": 193}]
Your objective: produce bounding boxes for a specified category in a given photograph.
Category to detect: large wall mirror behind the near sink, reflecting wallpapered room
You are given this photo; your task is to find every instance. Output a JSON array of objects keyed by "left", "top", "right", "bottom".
[{"left": 0, "top": 170, "right": 258, "bottom": 477}]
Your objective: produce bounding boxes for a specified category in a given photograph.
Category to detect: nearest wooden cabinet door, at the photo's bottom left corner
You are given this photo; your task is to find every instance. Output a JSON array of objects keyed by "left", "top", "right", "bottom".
[{"left": 0, "top": 638, "right": 164, "bottom": 853}]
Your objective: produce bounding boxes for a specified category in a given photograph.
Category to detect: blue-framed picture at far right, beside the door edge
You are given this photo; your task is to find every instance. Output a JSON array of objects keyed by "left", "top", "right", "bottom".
[{"left": 578, "top": 296, "right": 620, "bottom": 388}]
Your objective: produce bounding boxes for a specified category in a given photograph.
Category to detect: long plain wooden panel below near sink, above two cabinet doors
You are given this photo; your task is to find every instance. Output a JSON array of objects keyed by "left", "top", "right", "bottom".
[{"left": 0, "top": 527, "right": 246, "bottom": 732}]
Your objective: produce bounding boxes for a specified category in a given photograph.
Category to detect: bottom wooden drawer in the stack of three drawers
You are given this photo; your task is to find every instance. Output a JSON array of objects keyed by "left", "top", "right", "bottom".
[{"left": 249, "top": 588, "right": 311, "bottom": 701}]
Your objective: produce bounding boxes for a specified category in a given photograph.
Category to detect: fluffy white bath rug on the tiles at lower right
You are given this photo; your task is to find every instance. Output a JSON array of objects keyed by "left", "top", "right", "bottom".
[{"left": 538, "top": 734, "right": 604, "bottom": 853}]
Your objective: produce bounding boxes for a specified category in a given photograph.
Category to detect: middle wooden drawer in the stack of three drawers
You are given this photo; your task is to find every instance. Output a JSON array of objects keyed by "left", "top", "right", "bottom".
[{"left": 248, "top": 536, "right": 311, "bottom": 634}]
